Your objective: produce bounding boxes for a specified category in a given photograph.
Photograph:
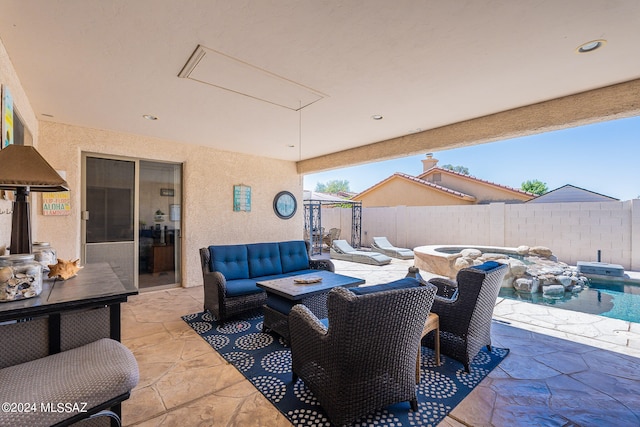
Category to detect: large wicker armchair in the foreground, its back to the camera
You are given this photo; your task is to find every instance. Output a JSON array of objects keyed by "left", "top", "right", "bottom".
[{"left": 289, "top": 278, "right": 436, "bottom": 425}]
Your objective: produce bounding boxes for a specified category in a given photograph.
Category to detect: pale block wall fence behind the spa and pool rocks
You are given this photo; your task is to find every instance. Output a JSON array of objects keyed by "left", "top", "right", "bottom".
[{"left": 322, "top": 199, "right": 640, "bottom": 271}]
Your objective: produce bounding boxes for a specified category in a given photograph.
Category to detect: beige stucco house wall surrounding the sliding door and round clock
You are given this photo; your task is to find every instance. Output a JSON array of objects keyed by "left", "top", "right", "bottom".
[{"left": 0, "top": 40, "right": 304, "bottom": 287}]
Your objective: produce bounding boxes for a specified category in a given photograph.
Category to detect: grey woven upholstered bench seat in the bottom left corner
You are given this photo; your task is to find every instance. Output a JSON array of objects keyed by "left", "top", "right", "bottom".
[{"left": 0, "top": 338, "right": 139, "bottom": 426}]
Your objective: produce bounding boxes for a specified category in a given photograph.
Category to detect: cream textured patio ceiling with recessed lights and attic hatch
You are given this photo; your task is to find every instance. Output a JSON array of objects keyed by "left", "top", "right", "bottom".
[{"left": 0, "top": 0, "right": 640, "bottom": 160}]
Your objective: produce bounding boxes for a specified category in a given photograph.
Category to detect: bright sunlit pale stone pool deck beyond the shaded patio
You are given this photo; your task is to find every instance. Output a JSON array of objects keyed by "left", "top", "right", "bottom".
[{"left": 332, "top": 259, "right": 640, "bottom": 358}]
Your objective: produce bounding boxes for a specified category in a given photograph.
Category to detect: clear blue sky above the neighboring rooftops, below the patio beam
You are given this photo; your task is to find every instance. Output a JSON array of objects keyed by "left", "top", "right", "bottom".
[{"left": 304, "top": 113, "right": 640, "bottom": 201}]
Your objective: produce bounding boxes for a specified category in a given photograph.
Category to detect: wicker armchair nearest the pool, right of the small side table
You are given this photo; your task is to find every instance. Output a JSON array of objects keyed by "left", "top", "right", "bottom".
[{"left": 422, "top": 261, "right": 507, "bottom": 372}]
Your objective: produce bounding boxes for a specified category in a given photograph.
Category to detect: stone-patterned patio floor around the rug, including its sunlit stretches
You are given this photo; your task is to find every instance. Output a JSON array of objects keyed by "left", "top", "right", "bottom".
[{"left": 122, "top": 260, "right": 640, "bottom": 427}]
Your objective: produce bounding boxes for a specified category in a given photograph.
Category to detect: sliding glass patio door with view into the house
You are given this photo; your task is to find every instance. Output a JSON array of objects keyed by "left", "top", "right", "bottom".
[{"left": 82, "top": 154, "right": 182, "bottom": 288}]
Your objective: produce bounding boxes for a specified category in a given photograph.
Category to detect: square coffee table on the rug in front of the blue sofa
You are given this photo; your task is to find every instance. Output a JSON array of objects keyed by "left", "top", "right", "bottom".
[{"left": 256, "top": 270, "right": 365, "bottom": 342}]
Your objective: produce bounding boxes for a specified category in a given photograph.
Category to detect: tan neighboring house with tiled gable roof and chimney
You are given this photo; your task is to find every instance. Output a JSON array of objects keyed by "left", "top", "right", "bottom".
[{"left": 353, "top": 154, "right": 535, "bottom": 207}]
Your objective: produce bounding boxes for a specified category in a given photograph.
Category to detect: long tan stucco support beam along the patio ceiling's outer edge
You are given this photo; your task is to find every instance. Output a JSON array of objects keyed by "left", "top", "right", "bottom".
[{"left": 297, "top": 79, "right": 640, "bottom": 174}]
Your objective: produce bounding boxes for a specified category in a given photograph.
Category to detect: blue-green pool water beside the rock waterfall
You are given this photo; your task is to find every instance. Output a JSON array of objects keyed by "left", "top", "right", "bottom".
[{"left": 499, "top": 281, "right": 640, "bottom": 323}]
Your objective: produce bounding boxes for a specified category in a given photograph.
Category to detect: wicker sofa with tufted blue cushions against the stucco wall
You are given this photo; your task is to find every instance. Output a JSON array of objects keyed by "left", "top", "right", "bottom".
[{"left": 200, "top": 240, "right": 335, "bottom": 321}]
